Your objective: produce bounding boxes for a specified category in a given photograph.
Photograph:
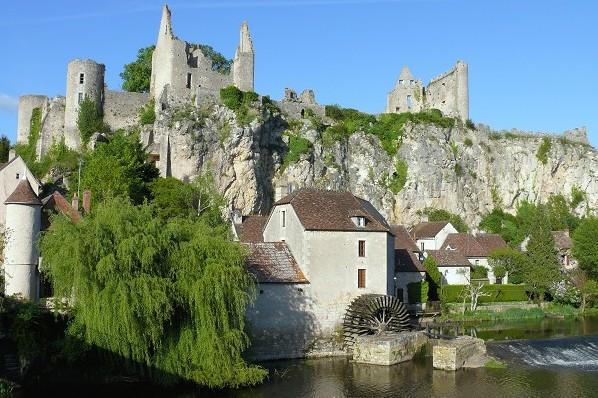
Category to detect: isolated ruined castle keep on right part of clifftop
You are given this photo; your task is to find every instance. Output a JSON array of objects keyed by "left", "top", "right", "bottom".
[{"left": 386, "top": 61, "right": 469, "bottom": 120}]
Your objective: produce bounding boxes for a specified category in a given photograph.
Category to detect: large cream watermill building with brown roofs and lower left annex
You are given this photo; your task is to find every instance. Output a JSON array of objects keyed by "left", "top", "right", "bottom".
[{"left": 233, "top": 189, "right": 395, "bottom": 359}]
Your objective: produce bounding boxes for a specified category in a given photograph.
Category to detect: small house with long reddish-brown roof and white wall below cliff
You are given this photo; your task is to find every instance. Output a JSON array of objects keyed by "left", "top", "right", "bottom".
[{"left": 441, "top": 233, "right": 507, "bottom": 284}]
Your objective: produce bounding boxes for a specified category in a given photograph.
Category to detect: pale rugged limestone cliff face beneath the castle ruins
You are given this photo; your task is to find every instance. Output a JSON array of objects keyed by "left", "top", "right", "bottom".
[{"left": 153, "top": 105, "right": 598, "bottom": 226}]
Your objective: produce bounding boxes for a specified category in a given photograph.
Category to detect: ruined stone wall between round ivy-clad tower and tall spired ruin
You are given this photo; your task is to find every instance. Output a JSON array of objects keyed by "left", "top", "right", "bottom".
[{"left": 104, "top": 89, "right": 149, "bottom": 131}]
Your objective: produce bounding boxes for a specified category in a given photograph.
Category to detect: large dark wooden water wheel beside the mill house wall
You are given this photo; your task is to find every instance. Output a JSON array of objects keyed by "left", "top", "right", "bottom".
[{"left": 343, "top": 294, "right": 410, "bottom": 350}]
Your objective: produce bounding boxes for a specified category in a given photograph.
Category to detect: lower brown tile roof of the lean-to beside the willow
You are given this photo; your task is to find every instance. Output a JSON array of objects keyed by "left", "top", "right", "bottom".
[{"left": 245, "top": 242, "right": 309, "bottom": 283}]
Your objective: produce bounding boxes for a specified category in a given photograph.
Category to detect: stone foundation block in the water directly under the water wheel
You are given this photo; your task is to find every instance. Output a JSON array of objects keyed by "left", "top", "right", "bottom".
[{"left": 353, "top": 332, "right": 428, "bottom": 365}]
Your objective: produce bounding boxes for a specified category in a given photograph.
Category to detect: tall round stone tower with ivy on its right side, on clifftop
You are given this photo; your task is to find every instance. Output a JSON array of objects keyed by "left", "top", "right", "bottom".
[{"left": 64, "top": 59, "right": 106, "bottom": 149}]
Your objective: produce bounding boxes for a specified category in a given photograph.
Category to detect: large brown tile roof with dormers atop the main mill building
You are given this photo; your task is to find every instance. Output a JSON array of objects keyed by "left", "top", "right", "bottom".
[{"left": 274, "top": 189, "right": 390, "bottom": 232}]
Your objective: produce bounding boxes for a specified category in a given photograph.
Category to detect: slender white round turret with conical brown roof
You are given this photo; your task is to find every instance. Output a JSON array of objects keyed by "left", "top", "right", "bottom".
[{"left": 4, "top": 179, "right": 42, "bottom": 300}]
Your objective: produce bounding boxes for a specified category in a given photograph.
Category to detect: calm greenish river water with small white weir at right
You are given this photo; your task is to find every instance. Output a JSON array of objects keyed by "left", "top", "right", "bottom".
[{"left": 27, "top": 318, "right": 598, "bottom": 398}]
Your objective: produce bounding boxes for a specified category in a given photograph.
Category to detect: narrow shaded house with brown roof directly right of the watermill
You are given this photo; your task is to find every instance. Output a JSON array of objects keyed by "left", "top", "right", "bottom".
[{"left": 390, "top": 225, "right": 426, "bottom": 303}]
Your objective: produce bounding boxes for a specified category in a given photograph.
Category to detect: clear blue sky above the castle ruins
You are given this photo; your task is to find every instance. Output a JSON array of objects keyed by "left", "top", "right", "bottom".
[{"left": 0, "top": 0, "right": 598, "bottom": 145}]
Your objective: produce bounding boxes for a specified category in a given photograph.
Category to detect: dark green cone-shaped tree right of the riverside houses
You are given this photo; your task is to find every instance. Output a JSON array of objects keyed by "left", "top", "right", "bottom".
[{"left": 522, "top": 210, "right": 560, "bottom": 301}]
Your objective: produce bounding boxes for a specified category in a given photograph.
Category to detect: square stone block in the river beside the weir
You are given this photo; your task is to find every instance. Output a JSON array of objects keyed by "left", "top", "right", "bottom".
[{"left": 432, "top": 336, "right": 486, "bottom": 370}]
